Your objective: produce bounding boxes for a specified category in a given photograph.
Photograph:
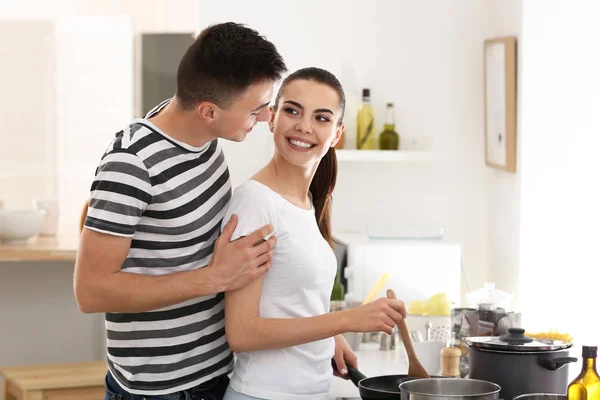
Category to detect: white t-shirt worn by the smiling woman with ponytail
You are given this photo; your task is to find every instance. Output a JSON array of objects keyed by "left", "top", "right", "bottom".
[{"left": 223, "top": 180, "right": 337, "bottom": 400}]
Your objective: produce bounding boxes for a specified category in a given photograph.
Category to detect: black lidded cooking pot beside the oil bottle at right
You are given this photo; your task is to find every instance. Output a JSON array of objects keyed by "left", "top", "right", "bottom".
[{"left": 466, "top": 328, "right": 577, "bottom": 400}]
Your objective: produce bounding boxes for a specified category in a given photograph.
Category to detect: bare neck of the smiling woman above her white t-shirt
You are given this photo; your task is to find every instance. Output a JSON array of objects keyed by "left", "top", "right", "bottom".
[{"left": 253, "top": 152, "right": 318, "bottom": 209}]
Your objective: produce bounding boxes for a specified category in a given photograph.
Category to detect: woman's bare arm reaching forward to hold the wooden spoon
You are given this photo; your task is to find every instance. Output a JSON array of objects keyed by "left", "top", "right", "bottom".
[{"left": 225, "top": 277, "right": 406, "bottom": 353}]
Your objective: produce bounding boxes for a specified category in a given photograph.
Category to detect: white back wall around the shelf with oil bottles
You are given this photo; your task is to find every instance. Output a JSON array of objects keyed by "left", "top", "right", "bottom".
[{"left": 198, "top": 0, "right": 513, "bottom": 302}]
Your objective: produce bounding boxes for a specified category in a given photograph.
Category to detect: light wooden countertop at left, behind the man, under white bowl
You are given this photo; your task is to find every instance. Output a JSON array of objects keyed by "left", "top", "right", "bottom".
[{"left": 0, "top": 235, "right": 79, "bottom": 262}]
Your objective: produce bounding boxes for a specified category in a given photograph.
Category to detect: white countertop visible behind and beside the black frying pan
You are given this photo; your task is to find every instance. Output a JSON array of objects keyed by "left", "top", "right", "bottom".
[{"left": 329, "top": 342, "right": 408, "bottom": 400}]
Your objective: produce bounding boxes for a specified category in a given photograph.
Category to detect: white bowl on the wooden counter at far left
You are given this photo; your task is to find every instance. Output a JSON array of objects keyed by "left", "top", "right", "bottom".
[{"left": 0, "top": 210, "right": 46, "bottom": 242}]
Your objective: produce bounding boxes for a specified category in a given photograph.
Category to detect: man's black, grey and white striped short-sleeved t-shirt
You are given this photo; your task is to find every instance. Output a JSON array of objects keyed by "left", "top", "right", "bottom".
[{"left": 85, "top": 100, "right": 233, "bottom": 395}]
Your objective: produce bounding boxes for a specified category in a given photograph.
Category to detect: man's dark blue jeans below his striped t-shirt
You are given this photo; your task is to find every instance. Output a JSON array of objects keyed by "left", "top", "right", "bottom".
[{"left": 104, "top": 371, "right": 229, "bottom": 400}]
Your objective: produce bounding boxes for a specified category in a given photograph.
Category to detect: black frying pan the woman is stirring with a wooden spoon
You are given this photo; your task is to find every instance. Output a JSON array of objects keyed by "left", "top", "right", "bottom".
[{"left": 332, "top": 360, "right": 441, "bottom": 400}]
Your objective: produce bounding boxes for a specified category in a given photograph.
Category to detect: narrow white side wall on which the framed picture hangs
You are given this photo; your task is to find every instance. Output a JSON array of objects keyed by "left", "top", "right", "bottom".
[{"left": 486, "top": 0, "right": 523, "bottom": 309}]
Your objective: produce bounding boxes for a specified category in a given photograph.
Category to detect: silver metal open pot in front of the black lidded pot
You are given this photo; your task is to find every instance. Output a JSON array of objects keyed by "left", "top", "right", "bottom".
[{"left": 400, "top": 378, "right": 500, "bottom": 400}]
